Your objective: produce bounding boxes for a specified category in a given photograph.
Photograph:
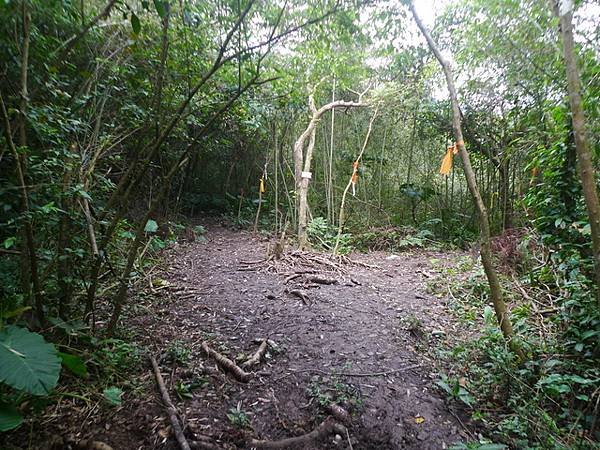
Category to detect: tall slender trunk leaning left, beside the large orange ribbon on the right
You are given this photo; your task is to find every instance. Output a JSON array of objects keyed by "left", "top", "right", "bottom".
[{"left": 409, "top": 2, "right": 525, "bottom": 359}]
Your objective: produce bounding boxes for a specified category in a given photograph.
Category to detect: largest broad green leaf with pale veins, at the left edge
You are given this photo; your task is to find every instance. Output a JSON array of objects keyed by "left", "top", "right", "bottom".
[{"left": 0, "top": 325, "right": 60, "bottom": 395}]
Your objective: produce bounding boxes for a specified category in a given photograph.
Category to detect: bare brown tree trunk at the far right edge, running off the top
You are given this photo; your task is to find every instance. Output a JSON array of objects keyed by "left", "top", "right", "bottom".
[{"left": 554, "top": 0, "right": 600, "bottom": 306}]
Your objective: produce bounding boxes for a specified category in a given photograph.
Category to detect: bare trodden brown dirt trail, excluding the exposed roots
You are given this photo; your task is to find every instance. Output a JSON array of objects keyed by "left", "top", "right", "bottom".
[{"left": 138, "top": 227, "right": 474, "bottom": 450}]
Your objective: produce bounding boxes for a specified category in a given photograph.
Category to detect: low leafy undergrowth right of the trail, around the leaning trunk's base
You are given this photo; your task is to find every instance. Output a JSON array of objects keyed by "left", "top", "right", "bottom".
[{"left": 430, "top": 237, "right": 600, "bottom": 449}]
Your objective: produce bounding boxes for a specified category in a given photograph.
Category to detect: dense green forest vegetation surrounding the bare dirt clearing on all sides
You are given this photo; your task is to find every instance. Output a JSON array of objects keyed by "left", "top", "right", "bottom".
[{"left": 0, "top": 0, "right": 600, "bottom": 449}]
